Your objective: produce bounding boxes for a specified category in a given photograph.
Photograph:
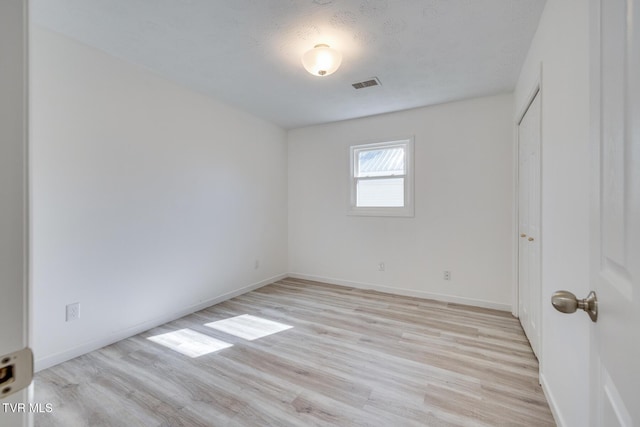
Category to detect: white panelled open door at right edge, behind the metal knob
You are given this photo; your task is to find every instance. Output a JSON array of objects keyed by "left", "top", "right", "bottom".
[{"left": 585, "top": 0, "right": 640, "bottom": 427}]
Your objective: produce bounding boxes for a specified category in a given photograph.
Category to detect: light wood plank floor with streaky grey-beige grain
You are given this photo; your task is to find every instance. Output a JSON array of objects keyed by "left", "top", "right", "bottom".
[{"left": 35, "top": 279, "right": 555, "bottom": 427}]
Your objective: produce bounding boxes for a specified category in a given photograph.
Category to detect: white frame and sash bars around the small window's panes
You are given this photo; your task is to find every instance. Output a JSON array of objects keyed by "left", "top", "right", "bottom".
[{"left": 347, "top": 136, "right": 414, "bottom": 217}]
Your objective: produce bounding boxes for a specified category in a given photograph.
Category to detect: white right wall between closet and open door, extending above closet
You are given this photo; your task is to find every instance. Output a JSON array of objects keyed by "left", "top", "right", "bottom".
[{"left": 515, "top": 0, "right": 590, "bottom": 426}]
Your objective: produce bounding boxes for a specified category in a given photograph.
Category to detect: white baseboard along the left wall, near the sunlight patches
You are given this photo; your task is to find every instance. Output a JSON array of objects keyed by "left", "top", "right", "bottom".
[{"left": 34, "top": 274, "right": 288, "bottom": 372}]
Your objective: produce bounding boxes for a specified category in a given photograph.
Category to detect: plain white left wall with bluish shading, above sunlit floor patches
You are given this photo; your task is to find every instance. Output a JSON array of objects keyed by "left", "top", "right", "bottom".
[{"left": 31, "top": 27, "right": 287, "bottom": 369}]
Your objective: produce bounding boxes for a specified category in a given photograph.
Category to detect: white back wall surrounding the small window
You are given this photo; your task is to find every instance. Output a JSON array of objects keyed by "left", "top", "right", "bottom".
[{"left": 289, "top": 95, "right": 514, "bottom": 310}]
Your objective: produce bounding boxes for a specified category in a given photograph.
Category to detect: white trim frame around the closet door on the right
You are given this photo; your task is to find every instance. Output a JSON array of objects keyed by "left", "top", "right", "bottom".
[{"left": 511, "top": 63, "right": 544, "bottom": 364}]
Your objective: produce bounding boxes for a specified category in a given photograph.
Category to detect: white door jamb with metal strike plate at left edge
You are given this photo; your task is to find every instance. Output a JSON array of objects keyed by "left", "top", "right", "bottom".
[{"left": 0, "top": 0, "right": 32, "bottom": 427}]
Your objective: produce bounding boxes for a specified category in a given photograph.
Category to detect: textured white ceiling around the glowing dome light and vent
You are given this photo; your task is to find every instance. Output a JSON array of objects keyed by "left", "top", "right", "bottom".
[{"left": 31, "top": 0, "right": 545, "bottom": 128}]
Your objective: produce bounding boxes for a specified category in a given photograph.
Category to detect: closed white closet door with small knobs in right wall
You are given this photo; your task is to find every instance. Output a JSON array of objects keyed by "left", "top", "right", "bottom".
[{"left": 518, "top": 91, "right": 540, "bottom": 357}]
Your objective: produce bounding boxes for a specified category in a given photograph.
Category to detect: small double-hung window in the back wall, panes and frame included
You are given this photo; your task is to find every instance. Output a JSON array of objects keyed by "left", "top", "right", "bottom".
[{"left": 349, "top": 138, "right": 413, "bottom": 216}]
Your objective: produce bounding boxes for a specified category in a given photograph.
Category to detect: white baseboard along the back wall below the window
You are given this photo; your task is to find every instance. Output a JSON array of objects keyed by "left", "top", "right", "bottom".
[{"left": 289, "top": 273, "right": 511, "bottom": 312}]
